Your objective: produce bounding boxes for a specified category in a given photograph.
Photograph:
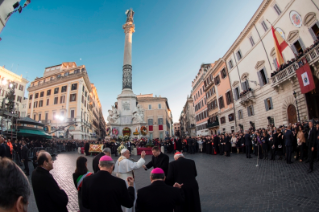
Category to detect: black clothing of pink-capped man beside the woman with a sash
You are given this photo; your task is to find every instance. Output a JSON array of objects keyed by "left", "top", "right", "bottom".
[{"left": 82, "top": 171, "right": 134, "bottom": 212}]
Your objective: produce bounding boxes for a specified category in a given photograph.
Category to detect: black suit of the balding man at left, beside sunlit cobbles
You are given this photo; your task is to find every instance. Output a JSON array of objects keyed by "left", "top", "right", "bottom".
[{"left": 31, "top": 166, "right": 68, "bottom": 212}]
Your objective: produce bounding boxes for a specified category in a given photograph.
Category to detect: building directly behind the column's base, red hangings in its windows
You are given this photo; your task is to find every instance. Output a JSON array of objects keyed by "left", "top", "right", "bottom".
[{"left": 136, "top": 94, "right": 174, "bottom": 140}]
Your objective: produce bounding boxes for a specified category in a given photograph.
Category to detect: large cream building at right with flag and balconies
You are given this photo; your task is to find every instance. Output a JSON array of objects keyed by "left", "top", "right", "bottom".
[{"left": 222, "top": 0, "right": 319, "bottom": 130}]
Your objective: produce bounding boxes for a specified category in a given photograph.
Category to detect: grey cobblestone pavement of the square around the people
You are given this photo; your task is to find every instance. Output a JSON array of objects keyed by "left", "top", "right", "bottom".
[{"left": 25, "top": 152, "right": 319, "bottom": 212}]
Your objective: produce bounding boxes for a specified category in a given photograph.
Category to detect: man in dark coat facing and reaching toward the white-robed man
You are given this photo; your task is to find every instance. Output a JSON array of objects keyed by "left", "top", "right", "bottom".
[{"left": 143, "top": 146, "right": 169, "bottom": 176}]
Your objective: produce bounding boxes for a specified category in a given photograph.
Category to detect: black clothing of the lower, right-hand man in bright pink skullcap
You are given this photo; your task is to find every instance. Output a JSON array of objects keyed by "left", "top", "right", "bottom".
[{"left": 135, "top": 181, "right": 184, "bottom": 212}]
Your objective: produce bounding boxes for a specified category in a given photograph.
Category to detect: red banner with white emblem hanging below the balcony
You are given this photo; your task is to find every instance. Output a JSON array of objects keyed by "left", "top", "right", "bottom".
[{"left": 296, "top": 63, "right": 316, "bottom": 94}]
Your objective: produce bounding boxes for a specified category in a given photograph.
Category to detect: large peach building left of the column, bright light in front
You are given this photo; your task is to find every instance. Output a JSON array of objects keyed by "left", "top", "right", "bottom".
[{"left": 27, "top": 62, "right": 105, "bottom": 139}]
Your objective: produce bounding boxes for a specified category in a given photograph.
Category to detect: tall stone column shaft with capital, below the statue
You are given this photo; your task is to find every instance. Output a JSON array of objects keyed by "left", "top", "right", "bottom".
[{"left": 122, "top": 20, "right": 135, "bottom": 90}]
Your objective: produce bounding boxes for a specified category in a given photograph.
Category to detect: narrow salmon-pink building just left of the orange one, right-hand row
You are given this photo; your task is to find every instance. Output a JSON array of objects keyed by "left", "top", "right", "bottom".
[{"left": 191, "top": 63, "right": 214, "bottom": 136}]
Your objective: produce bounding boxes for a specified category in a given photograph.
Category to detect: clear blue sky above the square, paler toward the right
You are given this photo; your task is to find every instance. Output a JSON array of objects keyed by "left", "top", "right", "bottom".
[{"left": 0, "top": 0, "right": 262, "bottom": 122}]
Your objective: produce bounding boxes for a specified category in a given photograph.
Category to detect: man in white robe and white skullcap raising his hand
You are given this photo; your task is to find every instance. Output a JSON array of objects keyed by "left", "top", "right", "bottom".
[{"left": 114, "top": 149, "right": 146, "bottom": 212}]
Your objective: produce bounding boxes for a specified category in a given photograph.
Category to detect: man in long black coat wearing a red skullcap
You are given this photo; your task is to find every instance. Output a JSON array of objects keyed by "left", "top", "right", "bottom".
[{"left": 166, "top": 152, "right": 201, "bottom": 212}]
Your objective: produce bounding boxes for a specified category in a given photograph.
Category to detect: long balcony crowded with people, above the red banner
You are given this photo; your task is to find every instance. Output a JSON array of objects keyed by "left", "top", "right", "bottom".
[{"left": 270, "top": 45, "right": 319, "bottom": 88}]
